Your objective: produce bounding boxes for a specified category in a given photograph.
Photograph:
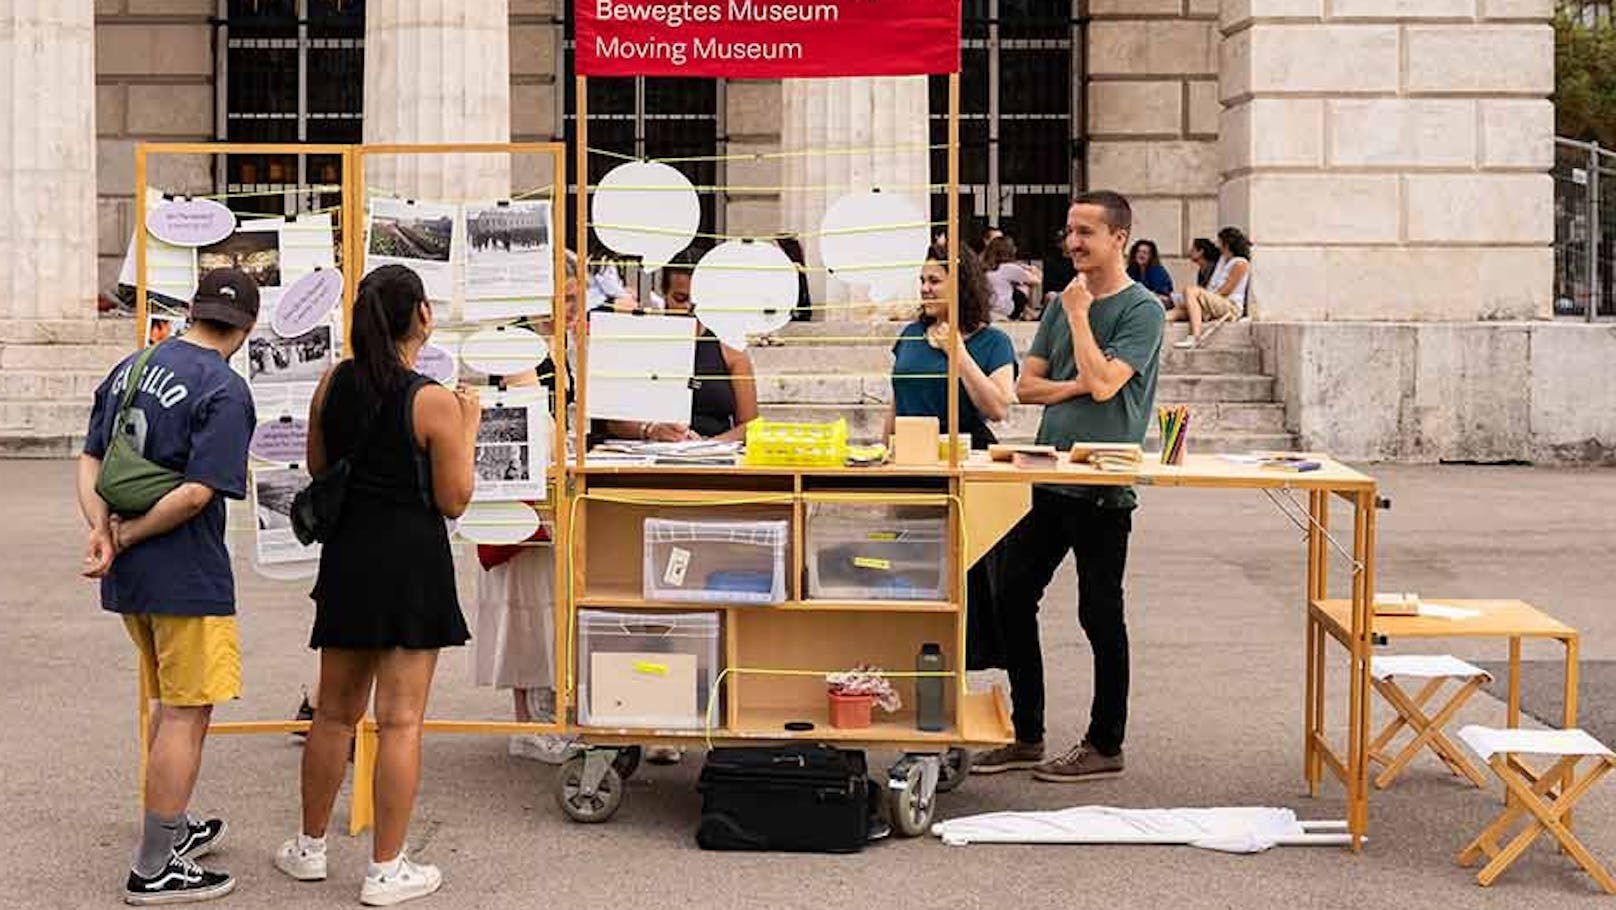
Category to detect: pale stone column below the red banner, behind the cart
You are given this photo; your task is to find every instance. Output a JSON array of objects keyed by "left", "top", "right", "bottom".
[{"left": 781, "top": 76, "right": 941, "bottom": 320}]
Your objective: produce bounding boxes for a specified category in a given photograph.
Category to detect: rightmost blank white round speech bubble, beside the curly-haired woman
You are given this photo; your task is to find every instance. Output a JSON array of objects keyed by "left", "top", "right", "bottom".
[{"left": 819, "top": 191, "right": 931, "bottom": 302}]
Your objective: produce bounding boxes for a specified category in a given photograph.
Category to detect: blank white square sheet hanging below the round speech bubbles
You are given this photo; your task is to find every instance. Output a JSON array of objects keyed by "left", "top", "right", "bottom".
[{"left": 587, "top": 312, "right": 696, "bottom": 423}]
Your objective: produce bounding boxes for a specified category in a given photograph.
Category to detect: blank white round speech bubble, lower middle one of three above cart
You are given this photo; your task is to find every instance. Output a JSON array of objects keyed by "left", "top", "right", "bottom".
[{"left": 690, "top": 241, "right": 797, "bottom": 348}]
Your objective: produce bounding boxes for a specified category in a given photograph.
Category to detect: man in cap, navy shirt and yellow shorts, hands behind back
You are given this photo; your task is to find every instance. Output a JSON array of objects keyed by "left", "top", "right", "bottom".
[{"left": 78, "top": 268, "right": 259, "bottom": 904}]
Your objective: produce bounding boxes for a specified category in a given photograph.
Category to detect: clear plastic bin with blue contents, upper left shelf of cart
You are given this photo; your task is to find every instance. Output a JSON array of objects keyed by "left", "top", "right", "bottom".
[{"left": 643, "top": 519, "right": 790, "bottom": 605}]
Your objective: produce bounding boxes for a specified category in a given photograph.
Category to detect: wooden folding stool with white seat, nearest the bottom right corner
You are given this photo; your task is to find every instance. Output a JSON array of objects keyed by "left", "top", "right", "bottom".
[{"left": 1459, "top": 726, "right": 1616, "bottom": 894}]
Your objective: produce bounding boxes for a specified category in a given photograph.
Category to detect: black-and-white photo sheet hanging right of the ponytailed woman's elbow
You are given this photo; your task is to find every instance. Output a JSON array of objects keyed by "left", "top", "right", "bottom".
[{"left": 472, "top": 388, "right": 551, "bottom": 499}]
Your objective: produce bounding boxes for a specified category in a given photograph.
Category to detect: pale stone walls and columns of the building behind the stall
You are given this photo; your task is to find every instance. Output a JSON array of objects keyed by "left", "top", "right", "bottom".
[{"left": 0, "top": 0, "right": 1616, "bottom": 461}]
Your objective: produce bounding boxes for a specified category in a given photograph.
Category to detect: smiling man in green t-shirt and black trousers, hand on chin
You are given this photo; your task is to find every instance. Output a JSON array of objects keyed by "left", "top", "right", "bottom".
[{"left": 971, "top": 192, "right": 1165, "bottom": 782}]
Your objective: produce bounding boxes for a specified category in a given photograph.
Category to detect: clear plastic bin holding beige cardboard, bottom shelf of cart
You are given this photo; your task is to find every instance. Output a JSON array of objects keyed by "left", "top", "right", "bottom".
[{"left": 579, "top": 609, "right": 719, "bottom": 731}]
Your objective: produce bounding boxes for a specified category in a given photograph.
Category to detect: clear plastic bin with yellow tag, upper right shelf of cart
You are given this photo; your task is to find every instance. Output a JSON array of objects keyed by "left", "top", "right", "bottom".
[{"left": 806, "top": 503, "right": 949, "bottom": 600}]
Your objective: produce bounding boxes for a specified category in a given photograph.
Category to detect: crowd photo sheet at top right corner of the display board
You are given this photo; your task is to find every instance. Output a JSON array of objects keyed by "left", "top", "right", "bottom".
[{"left": 465, "top": 200, "right": 556, "bottom": 320}]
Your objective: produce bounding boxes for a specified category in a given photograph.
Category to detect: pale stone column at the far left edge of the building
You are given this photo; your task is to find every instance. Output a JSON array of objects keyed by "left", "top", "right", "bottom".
[{"left": 0, "top": 0, "right": 102, "bottom": 454}]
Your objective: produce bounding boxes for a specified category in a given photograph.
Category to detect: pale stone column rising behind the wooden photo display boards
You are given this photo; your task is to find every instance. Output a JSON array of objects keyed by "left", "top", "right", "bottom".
[{"left": 365, "top": 0, "right": 511, "bottom": 202}]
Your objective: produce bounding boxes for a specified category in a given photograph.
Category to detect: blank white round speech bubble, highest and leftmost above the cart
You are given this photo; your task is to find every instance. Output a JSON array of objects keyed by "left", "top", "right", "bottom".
[{"left": 590, "top": 162, "right": 701, "bottom": 272}]
